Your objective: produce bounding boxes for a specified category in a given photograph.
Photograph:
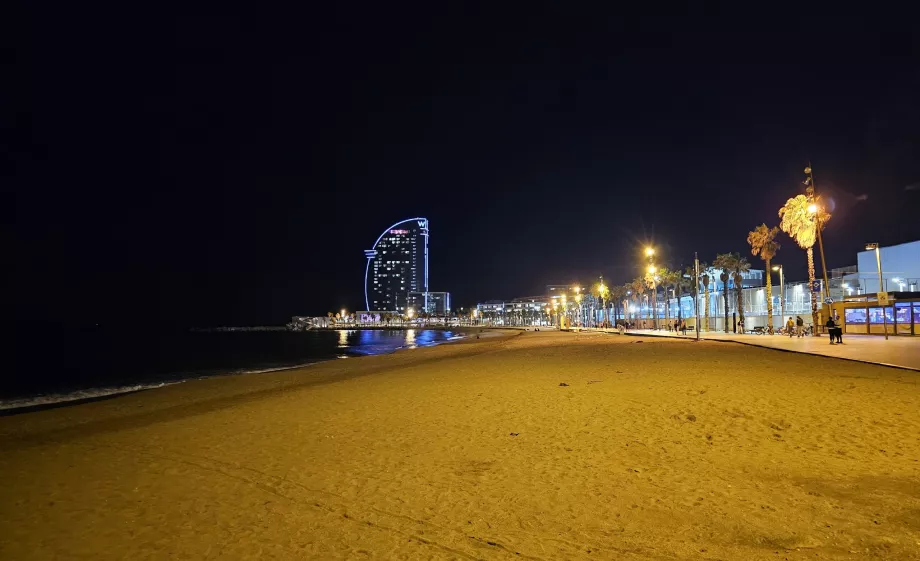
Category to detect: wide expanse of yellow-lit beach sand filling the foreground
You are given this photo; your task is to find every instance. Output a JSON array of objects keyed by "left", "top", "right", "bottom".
[{"left": 0, "top": 333, "right": 920, "bottom": 560}]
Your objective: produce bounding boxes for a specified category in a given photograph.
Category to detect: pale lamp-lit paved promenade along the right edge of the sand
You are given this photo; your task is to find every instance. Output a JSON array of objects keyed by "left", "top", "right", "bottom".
[{"left": 608, "top": 329, "right": 920, "bottom": 371}]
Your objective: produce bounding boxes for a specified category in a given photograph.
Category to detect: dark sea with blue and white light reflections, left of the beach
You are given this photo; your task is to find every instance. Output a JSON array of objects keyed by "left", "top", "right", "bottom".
[{"left": 0, "top": 328, "right": 462, "bottom": 415}]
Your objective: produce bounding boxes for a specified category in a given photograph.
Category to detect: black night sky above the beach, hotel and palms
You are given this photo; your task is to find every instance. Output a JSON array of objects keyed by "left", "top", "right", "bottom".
[{"left": 12, "top": 8, "right": 920, "bottom": 325}]
